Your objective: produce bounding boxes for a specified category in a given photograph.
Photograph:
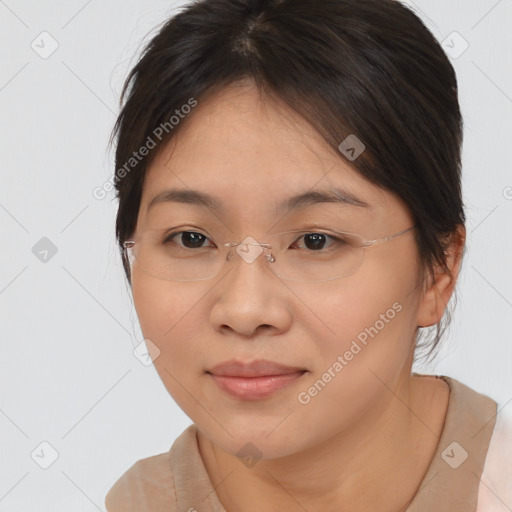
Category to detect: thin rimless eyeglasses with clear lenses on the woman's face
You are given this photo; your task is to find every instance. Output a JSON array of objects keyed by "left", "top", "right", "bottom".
[{"left": 123, "top": 226, "right": 416, "bottom": 282}]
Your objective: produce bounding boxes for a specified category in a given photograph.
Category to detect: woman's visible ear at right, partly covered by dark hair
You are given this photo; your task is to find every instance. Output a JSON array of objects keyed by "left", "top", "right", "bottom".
[{"left": 417, "top": 225, "right": 466, "bottom": 327}]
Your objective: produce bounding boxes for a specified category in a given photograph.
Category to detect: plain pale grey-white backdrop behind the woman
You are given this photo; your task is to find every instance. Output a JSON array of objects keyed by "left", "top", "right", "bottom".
[{"left": 0, "top": 0, "right": 512, "bottom": 512}]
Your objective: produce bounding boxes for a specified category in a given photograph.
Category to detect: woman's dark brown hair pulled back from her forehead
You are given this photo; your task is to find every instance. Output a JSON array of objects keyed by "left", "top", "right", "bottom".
[{"left": 110, "top": 0, "right": 465, "bottom": 364}]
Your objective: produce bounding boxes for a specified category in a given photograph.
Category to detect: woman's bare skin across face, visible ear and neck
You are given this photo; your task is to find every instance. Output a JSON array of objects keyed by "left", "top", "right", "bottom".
[{"left": 132, "top": 78, "right": 464, "bottom": 512}]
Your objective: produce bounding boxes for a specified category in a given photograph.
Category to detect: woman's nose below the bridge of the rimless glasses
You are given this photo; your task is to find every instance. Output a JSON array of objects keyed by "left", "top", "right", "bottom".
[{"left": 210, "top": 237, "right": 292, "bottom": 337}]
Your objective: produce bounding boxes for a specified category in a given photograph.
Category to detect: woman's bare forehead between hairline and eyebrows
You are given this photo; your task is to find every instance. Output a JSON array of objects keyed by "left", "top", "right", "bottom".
[{"left": 141, "top": 84, "right": 404, "bottom": 224}]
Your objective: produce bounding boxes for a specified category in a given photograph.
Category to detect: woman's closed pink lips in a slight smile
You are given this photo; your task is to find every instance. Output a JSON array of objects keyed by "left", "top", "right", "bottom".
[{"left": 207, "top": 360, "right": 306, "bottom": 400}]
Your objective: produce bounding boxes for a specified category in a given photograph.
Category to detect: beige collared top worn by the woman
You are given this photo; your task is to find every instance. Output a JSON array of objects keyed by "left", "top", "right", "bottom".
[{"left": 105, "top": 374, "right": 512, "bottom": 512}]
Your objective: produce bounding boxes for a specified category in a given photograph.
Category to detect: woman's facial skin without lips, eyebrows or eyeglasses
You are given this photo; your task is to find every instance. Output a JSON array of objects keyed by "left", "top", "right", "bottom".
[{"left": 132, "top": 81, "right": 421, "bottom": 459}]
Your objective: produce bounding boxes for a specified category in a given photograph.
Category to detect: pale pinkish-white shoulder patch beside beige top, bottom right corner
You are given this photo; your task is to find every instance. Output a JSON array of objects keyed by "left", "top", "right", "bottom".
[{"left": 477, "top": 403, "right": 512, "bottom": 512}]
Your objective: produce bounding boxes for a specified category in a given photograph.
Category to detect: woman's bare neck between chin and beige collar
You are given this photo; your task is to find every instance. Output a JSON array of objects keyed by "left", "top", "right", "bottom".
[{"left": 198, "top": 374, "right": 447, "bottom": 512}]
